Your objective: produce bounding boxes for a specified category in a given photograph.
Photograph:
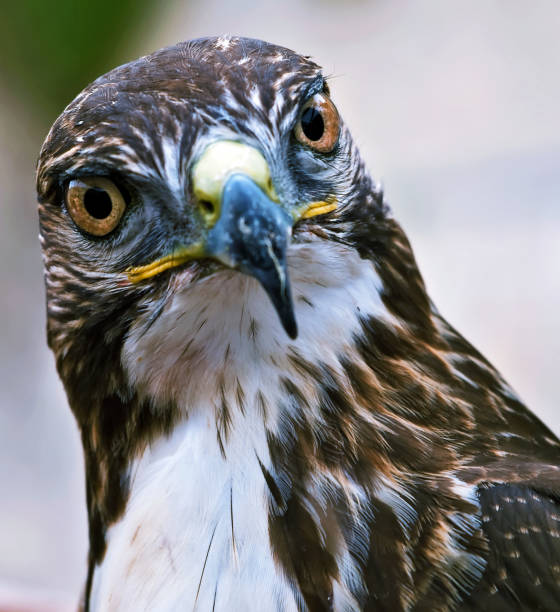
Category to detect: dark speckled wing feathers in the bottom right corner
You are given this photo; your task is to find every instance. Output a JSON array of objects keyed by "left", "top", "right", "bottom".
[{"left": 460, "top": 483, "right": 560, "bottom": 612}]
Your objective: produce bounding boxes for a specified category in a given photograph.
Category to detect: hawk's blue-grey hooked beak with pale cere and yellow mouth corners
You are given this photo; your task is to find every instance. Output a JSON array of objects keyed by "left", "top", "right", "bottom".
[{"left": 127, "top": 140, "right": 336, "bottom": 339}]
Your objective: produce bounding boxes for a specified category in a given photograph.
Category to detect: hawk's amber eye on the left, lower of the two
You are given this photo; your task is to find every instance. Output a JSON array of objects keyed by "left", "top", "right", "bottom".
[{"left": 66, "top": 177, "right": 126, "bottom": 236}]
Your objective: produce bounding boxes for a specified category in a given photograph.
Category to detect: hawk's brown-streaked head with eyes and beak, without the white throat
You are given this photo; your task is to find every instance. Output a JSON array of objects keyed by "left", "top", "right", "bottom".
[{"left": 37, "top": 38, "right": 398, "bottom": 354}]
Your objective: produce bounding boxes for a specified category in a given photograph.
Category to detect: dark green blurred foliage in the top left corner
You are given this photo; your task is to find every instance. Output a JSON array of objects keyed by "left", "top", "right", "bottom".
[{"left": 0, "top": 0, "right": 157, "bottom": 120}]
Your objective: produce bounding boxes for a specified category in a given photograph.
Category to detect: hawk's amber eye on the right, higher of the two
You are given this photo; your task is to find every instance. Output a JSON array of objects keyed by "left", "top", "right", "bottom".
[{"left": 294, "top": 94, "right": 340, "bottom": 153}]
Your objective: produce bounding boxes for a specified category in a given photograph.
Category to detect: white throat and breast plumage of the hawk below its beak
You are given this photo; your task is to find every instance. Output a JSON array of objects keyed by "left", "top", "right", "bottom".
[{"left": 91, "top": 241, "right": 391, "bottom": 612}]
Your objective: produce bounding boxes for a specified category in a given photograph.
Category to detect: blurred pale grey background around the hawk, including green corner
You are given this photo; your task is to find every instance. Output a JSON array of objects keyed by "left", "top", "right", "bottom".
[{"left": 0, "top": 0, "right": 560, "bottom": 609}]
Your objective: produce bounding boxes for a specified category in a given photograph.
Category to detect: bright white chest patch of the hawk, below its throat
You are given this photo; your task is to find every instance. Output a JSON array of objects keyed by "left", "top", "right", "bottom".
[{"left": 91, "top": 411, "right": 297, "bottom": 611}]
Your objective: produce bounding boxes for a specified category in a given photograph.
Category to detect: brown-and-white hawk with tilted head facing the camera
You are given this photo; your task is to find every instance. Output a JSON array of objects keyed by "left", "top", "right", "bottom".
[{"left": 37, "top": 37, "right": 560, "bottom": 612}]
